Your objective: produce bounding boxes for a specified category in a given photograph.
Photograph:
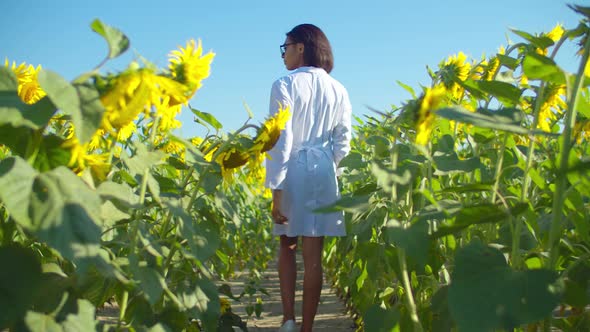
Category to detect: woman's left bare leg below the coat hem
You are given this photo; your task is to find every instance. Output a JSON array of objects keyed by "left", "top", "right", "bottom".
[{"left": 279, "top": 235, "right": 297, "bottom": 323}]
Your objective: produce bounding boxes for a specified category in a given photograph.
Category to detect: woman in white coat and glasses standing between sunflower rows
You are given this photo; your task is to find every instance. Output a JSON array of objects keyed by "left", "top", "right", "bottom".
[{"left": 266, "top": 24, "right": 352, "bottom": 331}]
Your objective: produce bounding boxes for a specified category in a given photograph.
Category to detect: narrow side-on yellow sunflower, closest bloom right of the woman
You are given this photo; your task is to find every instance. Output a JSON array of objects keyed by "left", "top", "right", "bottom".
[{"left": 416, "top": 85, "right": 446, "bottom": 145}]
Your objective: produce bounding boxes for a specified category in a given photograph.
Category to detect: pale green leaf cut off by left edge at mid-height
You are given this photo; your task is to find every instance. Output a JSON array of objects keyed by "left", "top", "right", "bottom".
[{"left": 0, "top": 157, "right": 37, "bottom": 229}]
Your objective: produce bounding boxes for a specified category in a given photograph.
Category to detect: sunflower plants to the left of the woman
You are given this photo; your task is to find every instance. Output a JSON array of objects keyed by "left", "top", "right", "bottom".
[{"left": 0, "top": 20, "right": 289, "bottom": 331}]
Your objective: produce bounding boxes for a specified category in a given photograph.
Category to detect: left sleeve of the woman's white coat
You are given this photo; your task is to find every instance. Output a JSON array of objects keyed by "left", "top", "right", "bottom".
[{"left": 265, "top": 80, "right": 293, "bottom": 190}]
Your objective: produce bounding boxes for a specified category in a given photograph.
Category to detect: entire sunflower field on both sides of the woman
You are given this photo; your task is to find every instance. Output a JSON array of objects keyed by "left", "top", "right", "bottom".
[{"left": 0, "top": 6, "right": 590, "bottom": 332}]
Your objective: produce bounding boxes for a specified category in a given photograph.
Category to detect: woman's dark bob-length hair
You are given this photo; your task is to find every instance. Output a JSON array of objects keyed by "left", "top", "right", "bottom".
[{"left": 287, "top": 24, "right": 334, "bottom": 73}]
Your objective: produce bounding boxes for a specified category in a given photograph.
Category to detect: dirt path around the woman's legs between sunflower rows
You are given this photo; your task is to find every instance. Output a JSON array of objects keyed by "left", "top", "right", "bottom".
[{"left": 229, "top": 255, "right": 355, "bottom": 332}]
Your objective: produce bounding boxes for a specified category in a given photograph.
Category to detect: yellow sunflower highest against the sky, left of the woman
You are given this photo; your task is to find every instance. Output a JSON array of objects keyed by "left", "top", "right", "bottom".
[{"left": 169, "top": 39, "right": 215, "bottom": 105}]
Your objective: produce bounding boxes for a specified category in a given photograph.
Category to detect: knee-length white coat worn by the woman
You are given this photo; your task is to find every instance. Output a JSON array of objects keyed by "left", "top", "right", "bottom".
[{"left": 265, "top": 67, "right": 352, "bottom": 237}]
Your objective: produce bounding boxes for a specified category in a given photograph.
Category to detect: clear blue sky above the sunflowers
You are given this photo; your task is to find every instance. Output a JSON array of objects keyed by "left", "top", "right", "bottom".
[{"left": 0, "top": 0, "right": 587, "bottom": 137}]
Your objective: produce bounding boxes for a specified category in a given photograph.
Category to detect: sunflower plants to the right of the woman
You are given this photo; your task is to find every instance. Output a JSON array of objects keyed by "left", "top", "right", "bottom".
[{"left": 324, "top": 6, "right": 590, "bottom": 332}]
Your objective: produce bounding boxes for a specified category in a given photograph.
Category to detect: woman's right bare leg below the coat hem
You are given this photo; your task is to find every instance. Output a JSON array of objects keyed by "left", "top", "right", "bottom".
[{"left": 301, "top": 236, "right": 324, "bottom": 332}]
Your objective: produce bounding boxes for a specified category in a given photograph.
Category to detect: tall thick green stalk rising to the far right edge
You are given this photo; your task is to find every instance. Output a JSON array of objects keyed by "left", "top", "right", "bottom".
[{"left": 549, "top": 32, "right": 590, "bottom": 269}]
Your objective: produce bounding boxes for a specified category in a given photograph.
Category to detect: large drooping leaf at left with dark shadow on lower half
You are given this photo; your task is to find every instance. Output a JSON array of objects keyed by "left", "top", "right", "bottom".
[{"left": 29, "top": 167, "right": 102, "bottom": 259}]
